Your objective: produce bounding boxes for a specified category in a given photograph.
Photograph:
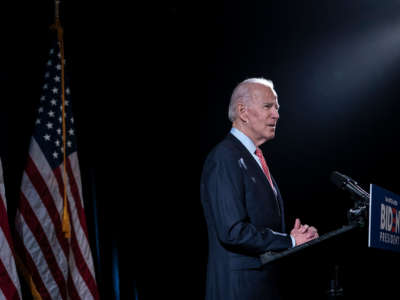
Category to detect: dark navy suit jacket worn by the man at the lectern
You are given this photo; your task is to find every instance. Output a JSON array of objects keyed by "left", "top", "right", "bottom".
[{"left": 201, "top": 134, "right": 292, "bottom": 300}]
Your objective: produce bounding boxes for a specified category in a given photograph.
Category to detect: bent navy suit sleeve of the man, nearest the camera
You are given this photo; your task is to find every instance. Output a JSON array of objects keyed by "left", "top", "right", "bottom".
[{"left": 202, "top": 149, "right": 292, "bottom": 255}]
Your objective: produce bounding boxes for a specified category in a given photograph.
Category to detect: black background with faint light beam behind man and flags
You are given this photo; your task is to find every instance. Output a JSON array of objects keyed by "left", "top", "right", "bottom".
[{"left": 0, "top": 0, "right": 400, "bottom": 299}]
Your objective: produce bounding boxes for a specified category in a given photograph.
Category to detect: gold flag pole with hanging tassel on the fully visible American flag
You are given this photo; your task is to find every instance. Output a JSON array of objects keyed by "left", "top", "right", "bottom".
[{"left": 51, "top": 0, "right": 71, "bottom": 239}]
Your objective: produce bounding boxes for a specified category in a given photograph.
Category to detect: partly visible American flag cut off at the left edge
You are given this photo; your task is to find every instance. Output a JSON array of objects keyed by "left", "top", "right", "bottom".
[{"left": 0, "top": 160, "right": 22, "bottom": 300}]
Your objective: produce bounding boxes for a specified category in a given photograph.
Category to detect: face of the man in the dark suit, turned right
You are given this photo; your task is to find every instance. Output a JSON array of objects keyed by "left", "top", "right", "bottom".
[{"left": 247, "top": 84, "right": 279, "bottom": 146}]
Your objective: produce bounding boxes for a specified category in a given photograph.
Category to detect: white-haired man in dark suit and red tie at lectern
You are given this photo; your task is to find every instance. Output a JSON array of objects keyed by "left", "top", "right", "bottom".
[{"left": 201, "top": 78, "right": 318, "bottom": 300}]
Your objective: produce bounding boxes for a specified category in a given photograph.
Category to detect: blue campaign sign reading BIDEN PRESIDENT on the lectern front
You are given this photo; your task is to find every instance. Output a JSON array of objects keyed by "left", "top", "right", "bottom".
[{"left": 368, "top": 184, "right": 400, "bottom": 252}]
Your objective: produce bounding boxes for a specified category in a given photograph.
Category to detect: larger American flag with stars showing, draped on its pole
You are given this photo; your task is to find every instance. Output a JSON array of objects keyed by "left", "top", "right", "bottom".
[{"left": 15, "top": 31, "right": 99, "bottom": 300}]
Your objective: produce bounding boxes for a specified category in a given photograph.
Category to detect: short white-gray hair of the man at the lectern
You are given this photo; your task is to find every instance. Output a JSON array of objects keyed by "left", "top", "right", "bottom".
[{"left": 228, "top": 78, "right": 275, "bottom": 122}]
